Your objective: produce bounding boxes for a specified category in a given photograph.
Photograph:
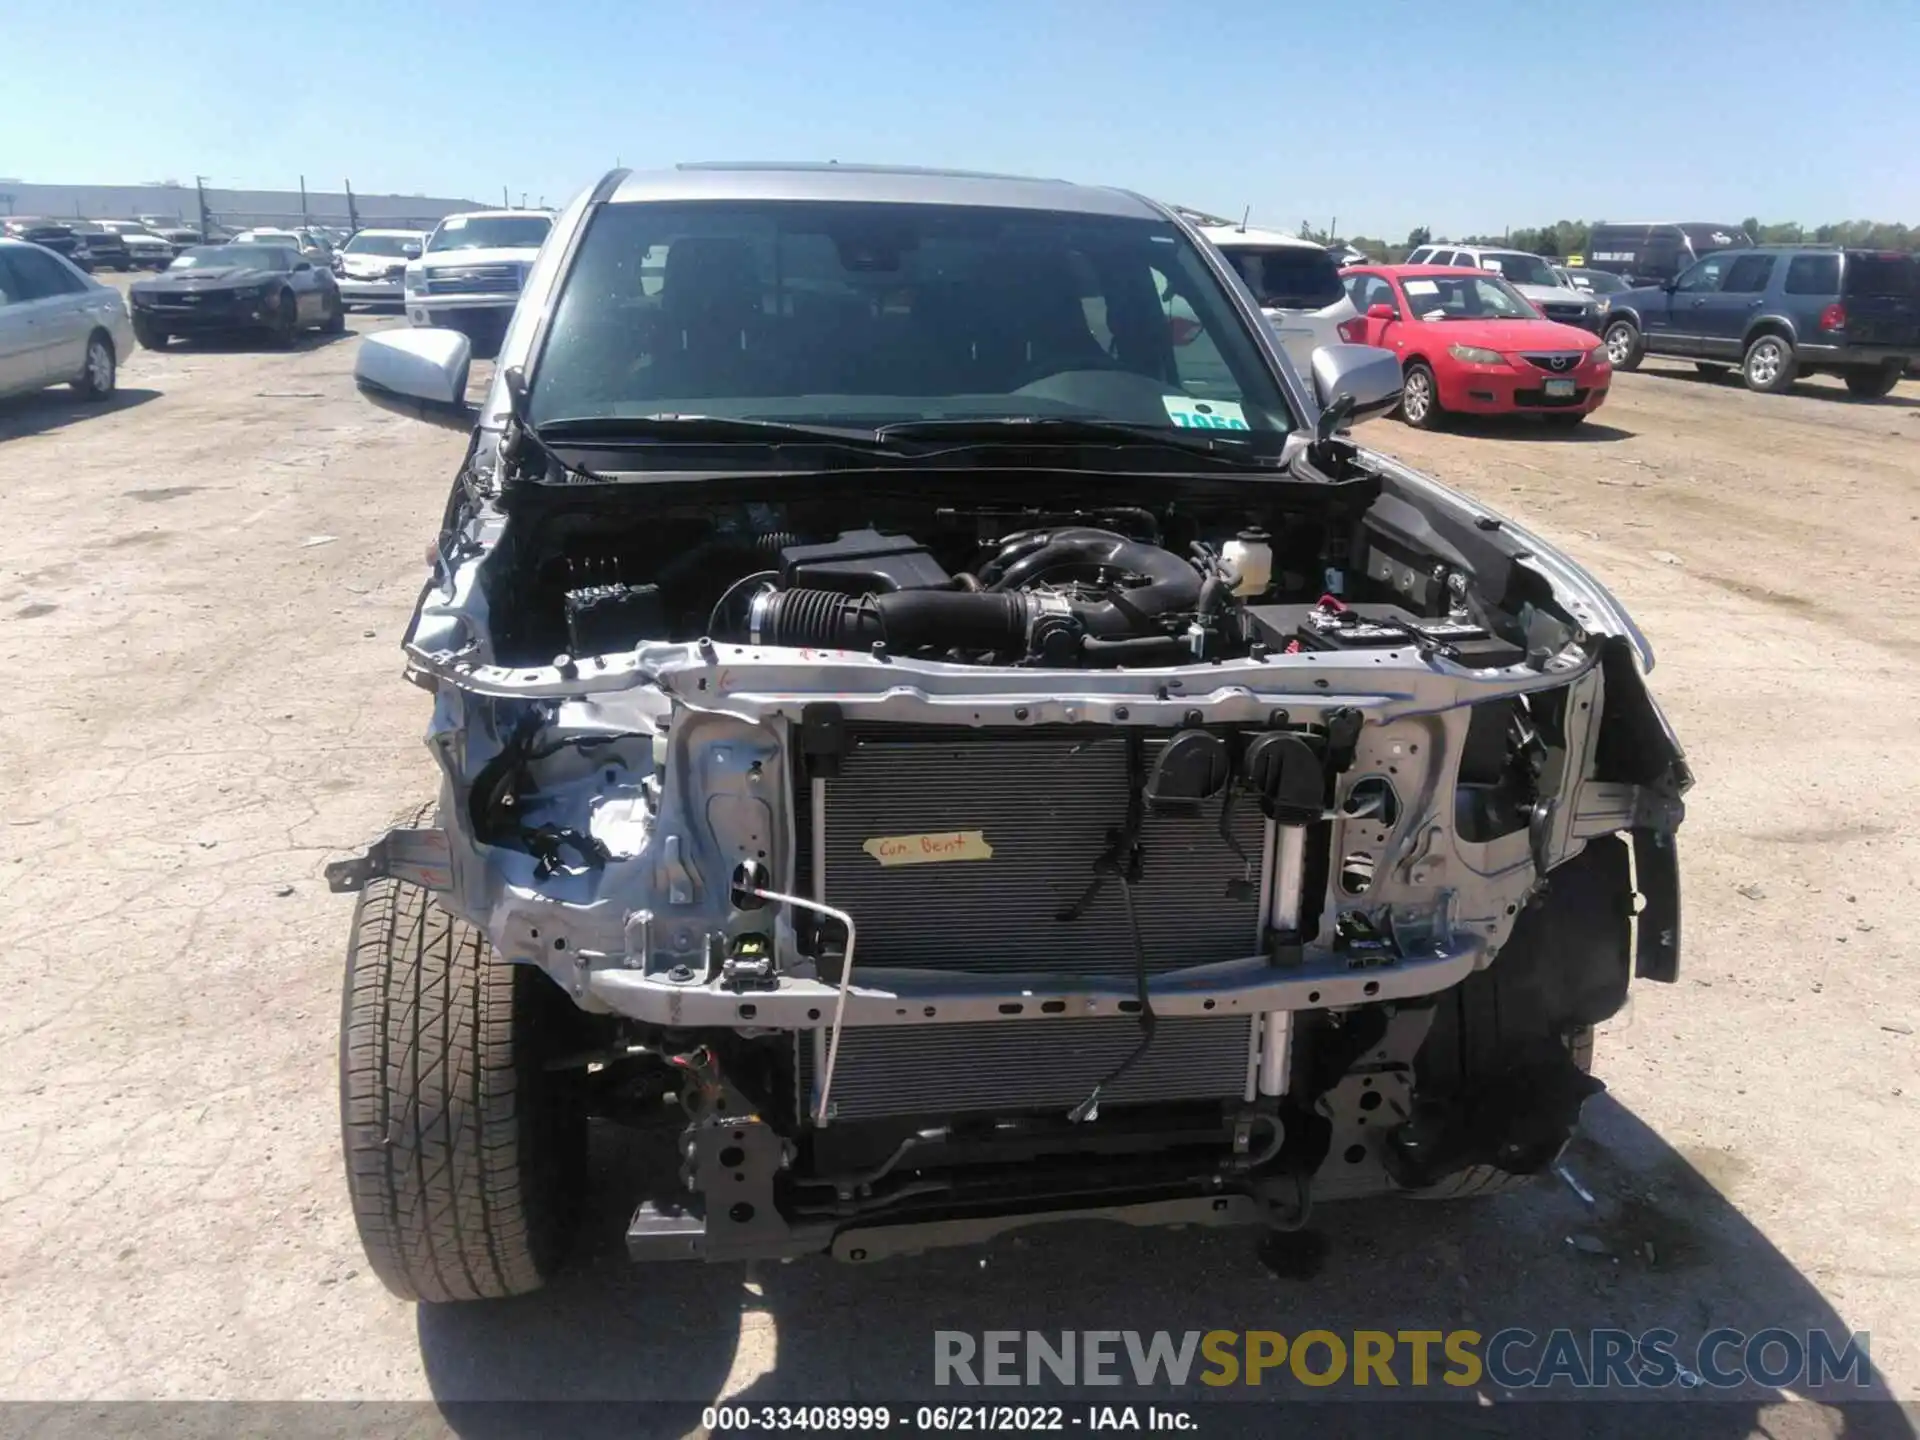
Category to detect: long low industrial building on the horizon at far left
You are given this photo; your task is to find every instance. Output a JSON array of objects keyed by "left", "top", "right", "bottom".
[{"left": 0, "top": 179, "right": 476, "bottom": 230}]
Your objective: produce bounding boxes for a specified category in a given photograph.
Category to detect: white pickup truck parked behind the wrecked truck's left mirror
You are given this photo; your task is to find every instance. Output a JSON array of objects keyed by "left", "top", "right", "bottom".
[{"left": 405, "top": 209, "right": 553, "bottom": 355}]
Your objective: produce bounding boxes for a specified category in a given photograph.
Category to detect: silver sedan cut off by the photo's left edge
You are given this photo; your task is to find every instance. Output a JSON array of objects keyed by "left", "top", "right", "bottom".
[{"left": 0, "top": 240, "right": 132, "bottom": 399}]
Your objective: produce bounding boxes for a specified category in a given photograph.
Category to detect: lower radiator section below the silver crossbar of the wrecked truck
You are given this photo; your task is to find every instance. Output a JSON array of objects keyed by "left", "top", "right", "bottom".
[{"left": 795, "top": 1016, "right": 1256, "bottom": 1121}]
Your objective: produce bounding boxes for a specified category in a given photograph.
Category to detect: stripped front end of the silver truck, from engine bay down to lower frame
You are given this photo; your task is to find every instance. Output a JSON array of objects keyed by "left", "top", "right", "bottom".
[{"left": 344, "top": 457, "right": 1688, "bottom": 1260}]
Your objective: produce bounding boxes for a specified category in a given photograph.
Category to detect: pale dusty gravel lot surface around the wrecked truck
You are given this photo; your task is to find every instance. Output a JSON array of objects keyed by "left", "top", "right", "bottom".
[{"left": 0, "top": 299, "right": 1920, "bottom": 1434}]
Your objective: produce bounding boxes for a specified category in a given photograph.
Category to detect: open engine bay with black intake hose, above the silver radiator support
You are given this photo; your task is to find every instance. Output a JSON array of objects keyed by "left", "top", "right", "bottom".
[{"left": 486, "top": 474, "right": 1543, "bottom": 668}]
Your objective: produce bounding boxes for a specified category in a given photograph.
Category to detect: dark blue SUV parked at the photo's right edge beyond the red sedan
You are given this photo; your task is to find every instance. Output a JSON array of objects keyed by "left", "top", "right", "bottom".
[{"left": 1603, "top": 246, "right": 1920, "bottom": 396}]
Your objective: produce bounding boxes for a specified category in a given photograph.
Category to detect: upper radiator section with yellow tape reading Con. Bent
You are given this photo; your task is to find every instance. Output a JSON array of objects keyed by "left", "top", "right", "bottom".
[{"left": 817, "top": 726, "right": 1265, "bottom": 983}]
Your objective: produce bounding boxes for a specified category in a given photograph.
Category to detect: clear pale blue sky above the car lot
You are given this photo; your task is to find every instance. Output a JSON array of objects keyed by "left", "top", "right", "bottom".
[{"left": 0, "top": 0, "right": 1920, "bottom": 240}]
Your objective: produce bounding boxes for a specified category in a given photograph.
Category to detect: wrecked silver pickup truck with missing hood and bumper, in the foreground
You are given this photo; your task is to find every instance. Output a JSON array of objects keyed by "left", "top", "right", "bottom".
[{"left": 328, "top": 165, "right": 1690, "bottom": 1300}]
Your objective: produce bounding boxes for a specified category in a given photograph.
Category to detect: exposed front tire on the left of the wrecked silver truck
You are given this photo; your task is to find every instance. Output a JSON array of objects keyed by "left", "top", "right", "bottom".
[{"left": 340, "top": 877, "right": 588, "bottom": 1304}]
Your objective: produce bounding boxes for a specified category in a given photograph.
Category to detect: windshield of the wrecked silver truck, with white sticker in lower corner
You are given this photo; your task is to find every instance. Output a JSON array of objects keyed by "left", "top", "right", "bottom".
[{"left": 532, "top": 202, "right": 1292, "bottom": 434}]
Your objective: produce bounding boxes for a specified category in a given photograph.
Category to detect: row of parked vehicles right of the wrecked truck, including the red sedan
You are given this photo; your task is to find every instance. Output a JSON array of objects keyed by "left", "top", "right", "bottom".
[{"left": 1221, "top": 213, "right": 1920, "bottom": 428}]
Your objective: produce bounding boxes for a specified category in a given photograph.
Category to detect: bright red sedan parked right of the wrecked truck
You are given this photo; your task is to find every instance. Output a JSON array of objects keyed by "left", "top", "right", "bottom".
[{"left": 1340, "top": 265, "right": 1613, "bottom": 430}]
